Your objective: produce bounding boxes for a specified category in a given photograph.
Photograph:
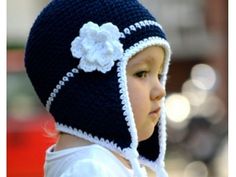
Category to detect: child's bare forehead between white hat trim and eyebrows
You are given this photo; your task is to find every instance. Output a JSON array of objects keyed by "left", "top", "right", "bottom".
[{"left": 129, "top": 46, "right": 165, "bottom": 65}]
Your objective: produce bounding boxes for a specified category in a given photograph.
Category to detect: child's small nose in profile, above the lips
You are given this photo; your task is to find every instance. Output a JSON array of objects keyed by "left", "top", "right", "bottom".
[{"left": 150, "top": 80, "right": 166, "bottom": 100}]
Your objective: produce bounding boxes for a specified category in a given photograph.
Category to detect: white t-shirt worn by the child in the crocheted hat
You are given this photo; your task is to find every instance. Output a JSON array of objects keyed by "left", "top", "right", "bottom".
[{"left": 44, "top": 144, "right": 146, "bottom": 177}]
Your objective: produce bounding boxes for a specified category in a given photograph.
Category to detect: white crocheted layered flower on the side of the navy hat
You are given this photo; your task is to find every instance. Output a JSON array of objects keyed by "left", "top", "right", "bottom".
[{"left": 71, "top": 22, "right": 124, "bottom": 73}]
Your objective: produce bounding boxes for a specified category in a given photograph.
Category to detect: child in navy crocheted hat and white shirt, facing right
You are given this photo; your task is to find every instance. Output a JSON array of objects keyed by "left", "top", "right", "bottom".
[{"left": 25, "top": 0, "right": 171, "bottom": 177}]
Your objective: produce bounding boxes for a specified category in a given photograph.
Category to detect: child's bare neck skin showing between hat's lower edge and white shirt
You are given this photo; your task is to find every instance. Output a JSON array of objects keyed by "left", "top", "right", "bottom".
[{"left": 54, "top": 133, "right": 131, "bottom": 169}]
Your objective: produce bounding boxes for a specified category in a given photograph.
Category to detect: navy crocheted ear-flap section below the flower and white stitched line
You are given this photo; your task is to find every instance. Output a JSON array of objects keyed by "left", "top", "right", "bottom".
[{"left": 51, "top": 63, "right": 131, "bottom": 147}]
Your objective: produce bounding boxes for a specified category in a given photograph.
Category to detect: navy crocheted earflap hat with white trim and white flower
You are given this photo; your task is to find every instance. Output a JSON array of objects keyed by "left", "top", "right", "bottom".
[{"left": 25, "top": 0, "right": 171, "bottom": 177}]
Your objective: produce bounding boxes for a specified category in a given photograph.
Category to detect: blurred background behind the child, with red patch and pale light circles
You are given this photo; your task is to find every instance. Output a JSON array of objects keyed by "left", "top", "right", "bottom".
[{"left": 7, "top": 0, "right": 228, "bottom": 177}]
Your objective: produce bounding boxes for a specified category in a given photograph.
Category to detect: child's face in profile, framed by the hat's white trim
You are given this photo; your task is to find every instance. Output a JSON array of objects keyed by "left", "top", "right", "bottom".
[{"left": 126, "top": 46, "right": 166, "bottom": 141}]
